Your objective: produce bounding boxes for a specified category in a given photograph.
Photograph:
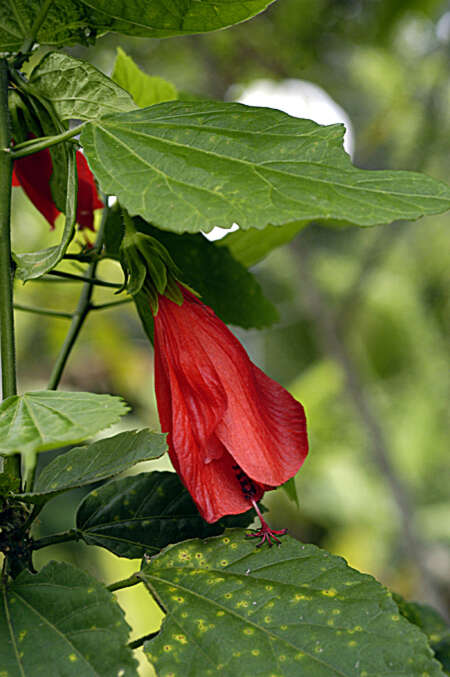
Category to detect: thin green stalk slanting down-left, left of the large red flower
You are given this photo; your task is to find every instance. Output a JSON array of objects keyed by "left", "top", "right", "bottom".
[{"left": 47, "top": 207, "right": 108, "bottom": 390}]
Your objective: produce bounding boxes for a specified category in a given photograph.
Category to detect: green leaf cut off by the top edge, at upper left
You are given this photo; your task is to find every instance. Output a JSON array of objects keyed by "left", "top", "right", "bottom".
[{"left": 0, "top": 0, "right": 273, "bottom": 51}]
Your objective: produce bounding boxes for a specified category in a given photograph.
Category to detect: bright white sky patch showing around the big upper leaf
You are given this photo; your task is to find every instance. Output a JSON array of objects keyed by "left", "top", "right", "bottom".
[{"left": 204, "top": 79, "right": 354, "bottom": 240}]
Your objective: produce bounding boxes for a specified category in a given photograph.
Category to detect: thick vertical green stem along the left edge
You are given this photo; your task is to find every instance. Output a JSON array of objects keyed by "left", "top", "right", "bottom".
[{"left": 0, "top": 59, "right": 20, "bottom": 480}]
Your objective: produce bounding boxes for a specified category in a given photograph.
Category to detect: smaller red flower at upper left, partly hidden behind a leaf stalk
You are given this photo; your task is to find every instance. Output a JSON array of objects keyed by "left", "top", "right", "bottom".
[{"left": 12, "top": 148, "right": 104, "bottom": 230}]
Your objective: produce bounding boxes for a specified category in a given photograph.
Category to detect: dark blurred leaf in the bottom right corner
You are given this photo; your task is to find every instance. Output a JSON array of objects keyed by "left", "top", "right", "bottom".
[{"left": 392, "top": 593, "right": 450, "bottom": 675}]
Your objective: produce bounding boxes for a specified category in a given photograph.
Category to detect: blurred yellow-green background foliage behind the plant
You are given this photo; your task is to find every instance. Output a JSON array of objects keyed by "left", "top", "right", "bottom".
[{"left": 8, "top": 0, "right": 450, "bottom": 674}]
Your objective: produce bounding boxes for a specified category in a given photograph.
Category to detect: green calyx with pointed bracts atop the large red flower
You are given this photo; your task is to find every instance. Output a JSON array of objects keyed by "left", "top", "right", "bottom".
[{"left": 119, "top": 212, "right": 183, "bottom": 315}]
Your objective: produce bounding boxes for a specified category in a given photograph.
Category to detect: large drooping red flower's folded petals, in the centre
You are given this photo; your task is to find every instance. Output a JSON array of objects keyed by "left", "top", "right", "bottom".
[{"left": 154, "top": 286, "right": 308, "bottom": 524}]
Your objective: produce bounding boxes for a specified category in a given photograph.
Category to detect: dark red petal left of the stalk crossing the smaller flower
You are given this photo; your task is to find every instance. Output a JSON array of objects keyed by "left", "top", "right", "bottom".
[{"left": 12, "top": 148, "right": 59, "bottom": 228}]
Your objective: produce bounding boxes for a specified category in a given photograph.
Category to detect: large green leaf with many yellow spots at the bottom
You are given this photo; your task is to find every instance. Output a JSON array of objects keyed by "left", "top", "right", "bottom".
[{"left": 143, "top": 530, "right": 443, "bottom": 677}]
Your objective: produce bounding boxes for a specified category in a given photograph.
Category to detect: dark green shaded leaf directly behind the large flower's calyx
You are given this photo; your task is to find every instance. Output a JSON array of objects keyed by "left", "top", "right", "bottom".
[{"left": 134, "top": 218, "right": 278, "bottom": 329}]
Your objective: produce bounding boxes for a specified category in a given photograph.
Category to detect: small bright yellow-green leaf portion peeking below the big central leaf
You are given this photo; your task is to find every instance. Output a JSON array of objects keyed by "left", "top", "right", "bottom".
[{"left": 217, "top": 221, "right": 309, "bottom": 268}]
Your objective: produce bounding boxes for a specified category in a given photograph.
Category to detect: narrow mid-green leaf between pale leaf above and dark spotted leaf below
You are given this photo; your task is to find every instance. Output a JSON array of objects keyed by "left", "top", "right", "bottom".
[{"left": 20, "top": 429, "right": 167, "bottom": 503}]
